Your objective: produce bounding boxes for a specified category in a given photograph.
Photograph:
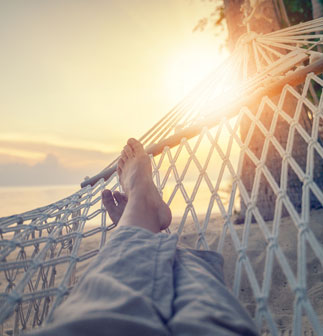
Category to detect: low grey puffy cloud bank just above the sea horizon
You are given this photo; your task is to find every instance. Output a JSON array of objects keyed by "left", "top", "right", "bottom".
[{"left": 0, "top": 154, "right": 98, "bottom": 186}]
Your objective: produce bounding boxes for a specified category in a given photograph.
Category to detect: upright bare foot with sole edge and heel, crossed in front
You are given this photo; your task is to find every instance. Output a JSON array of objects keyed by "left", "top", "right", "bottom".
[{"left": 117, "top": 139, "right": 172, "bottom": 232}]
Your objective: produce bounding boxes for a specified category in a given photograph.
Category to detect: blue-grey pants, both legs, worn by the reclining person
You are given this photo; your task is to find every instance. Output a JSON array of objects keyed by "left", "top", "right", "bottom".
[{"left": 28, "top": 226, "right": 258, "bottom": 336}]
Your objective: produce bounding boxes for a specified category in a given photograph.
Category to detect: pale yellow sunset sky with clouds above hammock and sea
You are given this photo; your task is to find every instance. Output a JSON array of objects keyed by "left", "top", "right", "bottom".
[{"left": 0, "top": 0, "right": 226, "bottom": 186}]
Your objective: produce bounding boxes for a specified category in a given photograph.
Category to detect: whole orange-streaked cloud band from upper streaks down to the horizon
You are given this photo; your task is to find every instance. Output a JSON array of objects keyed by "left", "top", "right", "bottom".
[{"left": 0, "top": 139, "right": 118, "bottom": 186}]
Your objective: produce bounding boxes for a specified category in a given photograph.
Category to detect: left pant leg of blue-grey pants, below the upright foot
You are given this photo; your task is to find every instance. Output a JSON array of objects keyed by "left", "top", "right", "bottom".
[{"left": 27, "top": 226, "right": 177, "bottom": 336}]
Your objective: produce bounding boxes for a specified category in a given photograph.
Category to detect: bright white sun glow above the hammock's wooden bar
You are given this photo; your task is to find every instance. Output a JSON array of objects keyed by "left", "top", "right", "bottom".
[{"left": 167, "top": 46, "right": 241, "bottom": 121}]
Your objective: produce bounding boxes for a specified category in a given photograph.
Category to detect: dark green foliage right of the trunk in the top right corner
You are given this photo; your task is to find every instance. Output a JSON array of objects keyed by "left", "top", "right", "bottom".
[{"left": 284, "top": 0, "right": 312, "bottom": 25}]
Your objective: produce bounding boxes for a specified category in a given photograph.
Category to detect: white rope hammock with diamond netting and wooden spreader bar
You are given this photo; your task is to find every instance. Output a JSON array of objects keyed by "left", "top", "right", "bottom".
[{"left": 0, "top": 18, "right": 323, "bottom": 335}]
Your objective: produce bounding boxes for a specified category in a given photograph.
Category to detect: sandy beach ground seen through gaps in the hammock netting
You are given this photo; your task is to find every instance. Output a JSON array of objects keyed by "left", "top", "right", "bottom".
[{"left": 0, "top": 209, "right": 323, "bottom": 335}]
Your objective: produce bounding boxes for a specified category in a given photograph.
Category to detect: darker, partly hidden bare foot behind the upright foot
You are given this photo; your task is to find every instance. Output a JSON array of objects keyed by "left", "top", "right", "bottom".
[{"left": 102, "top": 189, "right": 128, "bottom": 224}]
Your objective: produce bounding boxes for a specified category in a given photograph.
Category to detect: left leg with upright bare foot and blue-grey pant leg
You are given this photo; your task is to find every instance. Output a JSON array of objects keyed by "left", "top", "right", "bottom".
[{"left": 27, "top": 141, "right": 177, "bottom": 336}]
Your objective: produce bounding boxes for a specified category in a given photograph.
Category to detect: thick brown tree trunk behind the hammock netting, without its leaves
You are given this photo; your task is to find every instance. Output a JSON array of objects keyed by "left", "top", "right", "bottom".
[{"left": 224, "top": 0, "right": 323, "bottom": 224}]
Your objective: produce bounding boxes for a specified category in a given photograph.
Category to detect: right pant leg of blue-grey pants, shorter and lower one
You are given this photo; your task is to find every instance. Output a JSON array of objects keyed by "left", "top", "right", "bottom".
[{"left": 168, "top": 249, "right": 258, "bottom": 336}]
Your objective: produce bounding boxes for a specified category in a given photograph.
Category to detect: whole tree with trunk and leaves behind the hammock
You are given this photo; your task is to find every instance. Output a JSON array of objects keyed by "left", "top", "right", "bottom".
[{"left": 195, "top": 0, "right": 323, "bottom": 223}]
